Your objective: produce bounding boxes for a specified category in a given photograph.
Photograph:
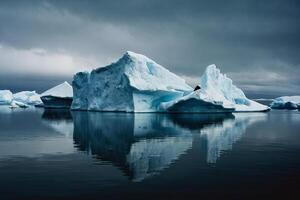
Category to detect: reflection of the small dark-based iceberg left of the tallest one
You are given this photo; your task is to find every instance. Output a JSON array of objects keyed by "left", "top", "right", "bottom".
[{"left": 42, "top": 109, "right": 74, "bottom": 138}]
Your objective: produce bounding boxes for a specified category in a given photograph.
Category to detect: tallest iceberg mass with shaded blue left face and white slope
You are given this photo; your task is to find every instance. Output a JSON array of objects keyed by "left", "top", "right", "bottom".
[{"left": 72, "top": 51, "right": 192, "bottom": 112}]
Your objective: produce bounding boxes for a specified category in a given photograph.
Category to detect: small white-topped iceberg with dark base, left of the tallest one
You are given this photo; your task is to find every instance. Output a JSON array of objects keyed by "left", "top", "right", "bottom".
[{"left": 41, "top": 82, "right": 73, "bottom": 108}]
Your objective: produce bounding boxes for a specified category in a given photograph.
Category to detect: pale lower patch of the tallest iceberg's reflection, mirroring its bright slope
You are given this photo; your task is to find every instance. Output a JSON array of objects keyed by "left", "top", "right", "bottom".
[{"left": 127, "top": 135, "right": 192, "bottom": 181}]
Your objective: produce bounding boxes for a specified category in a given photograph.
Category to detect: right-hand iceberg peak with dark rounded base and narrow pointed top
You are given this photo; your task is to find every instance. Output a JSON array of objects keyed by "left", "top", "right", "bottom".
[{"left": 161, "top": 65, "right": 269, "bottom": 112}]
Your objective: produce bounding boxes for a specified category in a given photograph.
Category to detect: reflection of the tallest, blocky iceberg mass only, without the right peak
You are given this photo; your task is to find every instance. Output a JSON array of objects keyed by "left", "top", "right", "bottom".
[{"left": 72, "top": 112, "right": 192, "bottom": 181}]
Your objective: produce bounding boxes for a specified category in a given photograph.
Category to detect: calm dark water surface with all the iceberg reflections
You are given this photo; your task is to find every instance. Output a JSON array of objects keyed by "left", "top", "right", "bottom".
[{"left": 0, "top": 108, "right": 300, "bottom": 200}]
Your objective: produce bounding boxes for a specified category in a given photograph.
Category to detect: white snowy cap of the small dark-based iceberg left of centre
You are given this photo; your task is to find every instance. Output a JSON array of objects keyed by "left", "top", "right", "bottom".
[{"left": 41, "top": 81, "right": 73, "bottom": 98}]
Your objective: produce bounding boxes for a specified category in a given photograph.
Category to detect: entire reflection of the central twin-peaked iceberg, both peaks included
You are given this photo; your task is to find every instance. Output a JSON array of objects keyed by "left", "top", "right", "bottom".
[{"left": 72, "top": 111, "right": 266, "bottom": 181}]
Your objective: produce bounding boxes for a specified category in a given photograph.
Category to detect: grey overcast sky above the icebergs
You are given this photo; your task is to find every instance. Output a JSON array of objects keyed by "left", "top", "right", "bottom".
[{"left": 0, "top": 0, "right": 300, "bottom": 95}]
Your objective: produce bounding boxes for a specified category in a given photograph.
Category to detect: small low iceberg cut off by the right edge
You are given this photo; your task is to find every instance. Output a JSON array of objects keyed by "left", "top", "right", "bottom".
[{"left": 270, "top": 96, "right": 300, "bottom": 110}]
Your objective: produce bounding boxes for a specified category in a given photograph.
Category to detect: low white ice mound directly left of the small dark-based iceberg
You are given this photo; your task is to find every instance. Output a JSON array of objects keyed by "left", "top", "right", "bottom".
[{"left": 13, "top": 91, "right": 42, "bottom": 105}]
